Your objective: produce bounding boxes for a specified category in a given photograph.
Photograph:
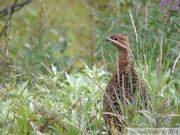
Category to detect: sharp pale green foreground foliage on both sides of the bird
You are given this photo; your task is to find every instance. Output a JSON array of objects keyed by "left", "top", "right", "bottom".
[{"left": 0, "top": 65, "right": 180, "bottom": 135}]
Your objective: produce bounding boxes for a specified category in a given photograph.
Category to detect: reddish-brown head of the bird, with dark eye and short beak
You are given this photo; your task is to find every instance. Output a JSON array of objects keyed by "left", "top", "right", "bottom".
[{"left": 106, "top": 33, "right": 129, "bottom": 51}]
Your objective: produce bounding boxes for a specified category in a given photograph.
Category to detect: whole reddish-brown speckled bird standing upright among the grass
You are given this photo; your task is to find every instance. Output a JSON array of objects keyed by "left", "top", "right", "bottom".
[{"left": 103, "top": 34, "right": 146, "bottom": 131}]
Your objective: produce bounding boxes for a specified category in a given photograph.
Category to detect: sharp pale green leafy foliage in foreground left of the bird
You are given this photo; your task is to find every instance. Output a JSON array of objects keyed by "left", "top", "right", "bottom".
[{"left": 0, "top": 65, "right": 105, "bottom": 134}]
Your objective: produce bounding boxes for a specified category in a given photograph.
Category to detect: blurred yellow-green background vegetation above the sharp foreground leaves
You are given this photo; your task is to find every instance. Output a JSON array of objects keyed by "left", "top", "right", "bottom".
[{"left": 0, "top": 0, "right": 180, "bottom": 77}]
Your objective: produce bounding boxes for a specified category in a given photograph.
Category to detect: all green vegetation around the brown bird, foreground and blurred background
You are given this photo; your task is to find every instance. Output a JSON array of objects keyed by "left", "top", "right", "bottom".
[{"left": 0, "top": 0, "right": 180, "bottom": 135}]
